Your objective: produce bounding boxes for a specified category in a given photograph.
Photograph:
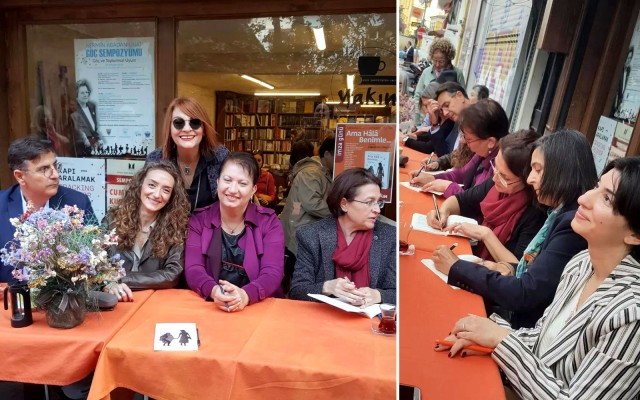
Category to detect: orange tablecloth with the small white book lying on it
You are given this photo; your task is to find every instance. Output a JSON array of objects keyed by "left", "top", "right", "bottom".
[{"left": 89, "top": 290, "right": 396, "bottom": 400}]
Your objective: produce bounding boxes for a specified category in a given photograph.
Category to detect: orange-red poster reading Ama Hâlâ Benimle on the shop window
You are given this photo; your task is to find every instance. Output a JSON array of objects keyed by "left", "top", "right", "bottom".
[{"left": 333, "top": 124, "right": 396, "bottom": 203}]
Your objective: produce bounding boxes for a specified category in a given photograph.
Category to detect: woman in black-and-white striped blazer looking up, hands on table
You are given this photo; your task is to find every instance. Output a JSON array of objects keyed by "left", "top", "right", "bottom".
[{"left": 440, "top": 157, "right": 640, "bottom": 400}]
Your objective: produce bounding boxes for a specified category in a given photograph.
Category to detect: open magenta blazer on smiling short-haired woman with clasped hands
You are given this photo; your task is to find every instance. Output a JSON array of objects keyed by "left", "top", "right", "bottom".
[{"left": 184, "top": 201, "right": 284, "bottom": 304}]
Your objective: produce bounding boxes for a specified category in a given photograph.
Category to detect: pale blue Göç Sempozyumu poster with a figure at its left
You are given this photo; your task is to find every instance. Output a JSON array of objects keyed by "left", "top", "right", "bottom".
[{"left": 71, "top": 38, "right": 155, "bottom": 158}]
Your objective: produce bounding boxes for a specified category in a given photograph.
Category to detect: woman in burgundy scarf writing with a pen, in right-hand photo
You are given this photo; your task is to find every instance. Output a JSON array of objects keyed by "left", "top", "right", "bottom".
[{"left": 427, "top": 130, "right": 545, "bottom": 263}]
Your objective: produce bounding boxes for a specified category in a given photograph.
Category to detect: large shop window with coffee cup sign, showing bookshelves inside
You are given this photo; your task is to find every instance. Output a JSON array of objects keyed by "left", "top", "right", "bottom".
[{"left": 176, "top": 13, "right": 396, "bottom": 170}]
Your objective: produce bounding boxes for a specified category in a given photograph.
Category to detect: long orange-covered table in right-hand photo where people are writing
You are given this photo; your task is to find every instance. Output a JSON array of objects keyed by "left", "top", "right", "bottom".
[{"left": 399, "top": 147, "right": 504, "bottom": 400}]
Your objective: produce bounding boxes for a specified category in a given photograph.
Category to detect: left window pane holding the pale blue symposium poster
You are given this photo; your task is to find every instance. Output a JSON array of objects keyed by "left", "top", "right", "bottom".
[{"left": 26, "top": 22, "right": 156, "bottom": 158}]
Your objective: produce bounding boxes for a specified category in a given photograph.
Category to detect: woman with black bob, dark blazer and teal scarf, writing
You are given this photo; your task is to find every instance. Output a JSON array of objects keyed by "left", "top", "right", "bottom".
[{"left": 433, "top": 130, "right": 597, "bottom": 328}]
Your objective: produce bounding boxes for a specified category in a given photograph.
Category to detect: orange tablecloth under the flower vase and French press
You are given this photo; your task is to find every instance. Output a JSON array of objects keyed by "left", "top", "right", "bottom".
[{"left": 0, "top": 290, "right": 153, "bottom": 386}]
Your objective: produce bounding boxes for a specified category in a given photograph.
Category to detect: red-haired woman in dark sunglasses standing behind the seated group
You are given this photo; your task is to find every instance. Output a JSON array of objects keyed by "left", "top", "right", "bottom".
[{"left": 147, "top": 97, "right": 229, "bottom": 212}]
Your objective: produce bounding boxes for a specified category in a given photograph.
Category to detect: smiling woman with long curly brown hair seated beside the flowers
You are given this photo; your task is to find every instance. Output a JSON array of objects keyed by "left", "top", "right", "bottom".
[{"left": 103, "top": 161, "right": 189, "bottom": 301}]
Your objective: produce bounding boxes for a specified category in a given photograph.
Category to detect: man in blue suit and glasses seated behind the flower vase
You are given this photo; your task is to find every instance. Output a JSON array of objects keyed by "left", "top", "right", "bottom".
[{"left": 0, "top": 137, "right": 95, "bottom": 282}]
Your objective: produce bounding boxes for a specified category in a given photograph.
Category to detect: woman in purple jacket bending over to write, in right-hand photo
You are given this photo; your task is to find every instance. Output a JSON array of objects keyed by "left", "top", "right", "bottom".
[{"left": 410, "top": 99, "right": 509, "bottom": 198}]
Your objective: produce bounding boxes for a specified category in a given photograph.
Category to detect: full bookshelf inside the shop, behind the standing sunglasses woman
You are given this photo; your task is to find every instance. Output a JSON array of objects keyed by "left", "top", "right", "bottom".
[{"left": 216, "top": 91, "right": 323, "bottom": 166}]
